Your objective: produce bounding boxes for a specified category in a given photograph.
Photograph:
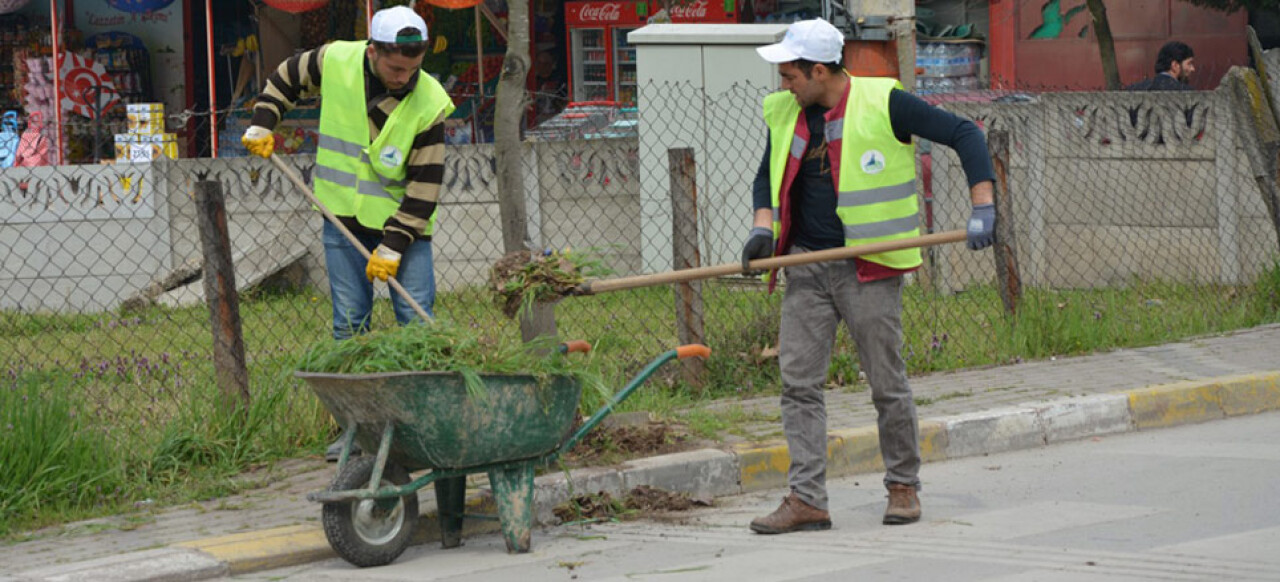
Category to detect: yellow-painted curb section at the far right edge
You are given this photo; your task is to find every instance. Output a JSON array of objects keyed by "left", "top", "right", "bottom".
[{"left": 1125, "top": 372, "right": 1280, "bottom": 430}]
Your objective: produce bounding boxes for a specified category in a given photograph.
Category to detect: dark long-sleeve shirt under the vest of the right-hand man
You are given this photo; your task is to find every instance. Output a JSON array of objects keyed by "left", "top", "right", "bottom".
[{"left": 751, "top": 90, "right": 996, "bottom": 251}]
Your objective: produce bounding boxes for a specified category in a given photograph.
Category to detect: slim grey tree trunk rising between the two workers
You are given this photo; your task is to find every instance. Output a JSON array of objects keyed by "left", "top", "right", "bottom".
[{"left": 493, "top": 3, "right": 556, "bottom": 342}]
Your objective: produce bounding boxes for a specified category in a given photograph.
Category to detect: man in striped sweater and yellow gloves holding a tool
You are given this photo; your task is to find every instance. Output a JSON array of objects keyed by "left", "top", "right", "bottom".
[{"left": 241, "top": 6, "right": 453, "bottom": 459}]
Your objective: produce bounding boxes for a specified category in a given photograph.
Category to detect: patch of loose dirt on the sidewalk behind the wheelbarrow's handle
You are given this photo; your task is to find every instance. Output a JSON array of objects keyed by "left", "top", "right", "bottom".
[{"left": 563, "top": 422, "right": 698, "bottom": 467}]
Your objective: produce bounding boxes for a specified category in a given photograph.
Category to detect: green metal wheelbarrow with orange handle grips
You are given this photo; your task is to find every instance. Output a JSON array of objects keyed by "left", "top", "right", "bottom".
[{"left": 297, "top": 342, "right": 710, "bottom": 567}]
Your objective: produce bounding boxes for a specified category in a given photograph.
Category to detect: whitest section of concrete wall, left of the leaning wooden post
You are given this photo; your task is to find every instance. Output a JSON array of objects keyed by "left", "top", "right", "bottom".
[{"left": 0, "top": 165, "right": 172, "bottom": 311}]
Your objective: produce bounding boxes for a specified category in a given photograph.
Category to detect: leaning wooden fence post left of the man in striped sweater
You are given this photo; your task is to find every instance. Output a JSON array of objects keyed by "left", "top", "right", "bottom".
[{"left": 196, "top": 180, "right": 250, "bottom": 408}]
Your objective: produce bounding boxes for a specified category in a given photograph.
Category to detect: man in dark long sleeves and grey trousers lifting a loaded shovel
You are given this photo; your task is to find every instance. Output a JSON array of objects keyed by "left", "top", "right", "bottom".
[{"left": 742, "top": 19, "right": 996, "bottom": 533}]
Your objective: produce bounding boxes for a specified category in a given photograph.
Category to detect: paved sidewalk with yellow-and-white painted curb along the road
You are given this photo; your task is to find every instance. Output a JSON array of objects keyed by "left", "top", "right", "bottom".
[{"left": 0, "top": 325, "right": 1280, "bottom": 582}]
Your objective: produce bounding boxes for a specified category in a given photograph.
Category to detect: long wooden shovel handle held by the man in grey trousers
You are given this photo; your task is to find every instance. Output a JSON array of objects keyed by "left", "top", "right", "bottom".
[{"left": 572, "top": 230, "right": 965, "bottom": 295}]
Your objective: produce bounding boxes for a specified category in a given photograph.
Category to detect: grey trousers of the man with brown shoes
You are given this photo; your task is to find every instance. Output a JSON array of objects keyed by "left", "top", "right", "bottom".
[{"left": 778, "top": 253, "right": 920, "bottom": 509}]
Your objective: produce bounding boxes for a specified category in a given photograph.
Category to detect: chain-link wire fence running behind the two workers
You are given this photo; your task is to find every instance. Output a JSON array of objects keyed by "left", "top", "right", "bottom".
[{"left": 0, "top": 69, "right": 1280, "bottom": 460}]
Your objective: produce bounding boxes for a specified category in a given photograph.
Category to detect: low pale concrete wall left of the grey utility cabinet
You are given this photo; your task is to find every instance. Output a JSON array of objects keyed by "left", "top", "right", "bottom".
[{"left": 0, "top": 139, "right": 640, "bottom": 312}]
